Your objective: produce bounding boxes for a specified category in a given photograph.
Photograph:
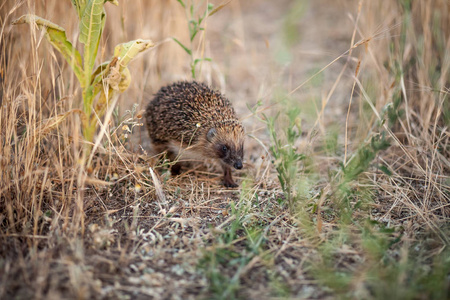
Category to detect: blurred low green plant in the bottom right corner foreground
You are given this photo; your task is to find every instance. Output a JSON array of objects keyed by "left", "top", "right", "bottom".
[{"left": 312, "top": 219, "right": 450, "bottom": 299}]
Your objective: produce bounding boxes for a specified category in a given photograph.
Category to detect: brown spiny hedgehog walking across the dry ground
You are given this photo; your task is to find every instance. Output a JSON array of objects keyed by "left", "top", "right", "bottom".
[{"left": 145, "top": 81, "right": 244, "bottom": 187}]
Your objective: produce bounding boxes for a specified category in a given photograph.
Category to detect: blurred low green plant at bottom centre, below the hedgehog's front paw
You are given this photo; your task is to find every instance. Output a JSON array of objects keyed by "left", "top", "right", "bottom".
[{"left": 197, "top": 182, "right": 270, "bottom": 299}]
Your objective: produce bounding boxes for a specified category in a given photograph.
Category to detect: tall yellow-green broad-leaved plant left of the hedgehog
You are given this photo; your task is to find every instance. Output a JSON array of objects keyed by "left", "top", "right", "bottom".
[{"left": 13, "top": 0, "right": 153, "bottom": 153}]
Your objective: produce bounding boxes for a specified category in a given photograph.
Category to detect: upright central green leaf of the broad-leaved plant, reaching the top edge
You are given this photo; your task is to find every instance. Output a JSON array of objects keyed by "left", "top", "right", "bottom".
[{"left": 79, "top": 0, "right": 106, "bottom": 84}]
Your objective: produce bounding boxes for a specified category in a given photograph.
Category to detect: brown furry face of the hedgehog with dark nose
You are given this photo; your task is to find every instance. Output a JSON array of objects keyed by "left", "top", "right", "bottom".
[{"left": 207, "top": 128, "right": 244, "bottom": 169}]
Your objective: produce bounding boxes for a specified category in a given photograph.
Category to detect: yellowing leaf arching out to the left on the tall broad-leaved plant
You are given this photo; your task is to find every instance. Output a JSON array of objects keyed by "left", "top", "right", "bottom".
[{"left": 12, "top": 14, "right": 84, "bottom": 87}]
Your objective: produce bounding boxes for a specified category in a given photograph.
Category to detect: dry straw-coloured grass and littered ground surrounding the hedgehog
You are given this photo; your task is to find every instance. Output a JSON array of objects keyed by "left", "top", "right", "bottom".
[{"left": 0, "top": 0, "right": 450, "bottom": 299}]
